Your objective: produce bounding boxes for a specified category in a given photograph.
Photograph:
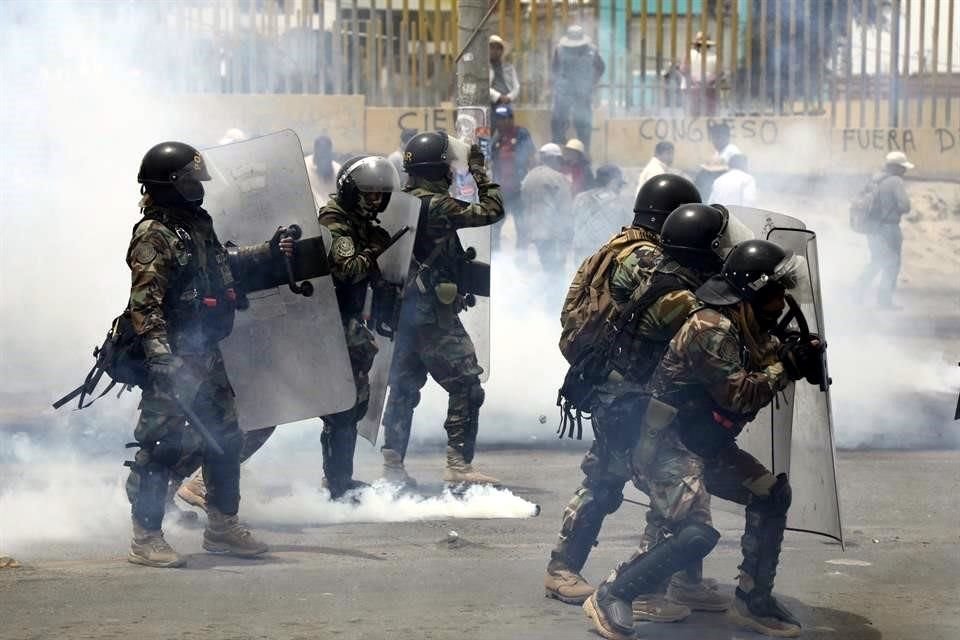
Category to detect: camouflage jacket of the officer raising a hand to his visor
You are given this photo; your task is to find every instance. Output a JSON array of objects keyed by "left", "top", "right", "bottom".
[{"left": 404, "top": 175, "right": 504, "bottom": 324}]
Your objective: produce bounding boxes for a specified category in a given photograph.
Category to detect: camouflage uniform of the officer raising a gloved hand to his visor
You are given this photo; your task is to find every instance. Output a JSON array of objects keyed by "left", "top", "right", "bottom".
[{"left": 383, "top": 172, "right": 504, "bottom": 463}]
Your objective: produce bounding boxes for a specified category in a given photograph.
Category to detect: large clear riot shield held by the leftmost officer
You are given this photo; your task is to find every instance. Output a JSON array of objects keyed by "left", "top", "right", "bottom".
[{"left": 203, "top": 130, "right": 357, "bottom": 431}]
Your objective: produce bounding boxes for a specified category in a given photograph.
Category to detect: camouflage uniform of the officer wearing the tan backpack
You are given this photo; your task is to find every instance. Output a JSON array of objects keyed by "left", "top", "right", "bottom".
[{"left": 547, "top": 228, "right": 663, "bottom": 573}]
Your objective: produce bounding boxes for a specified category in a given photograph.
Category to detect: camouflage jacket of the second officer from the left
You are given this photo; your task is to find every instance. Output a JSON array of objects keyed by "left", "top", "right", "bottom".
[{"left": 317, "top": 198, "right": 390, "bottom": 322}]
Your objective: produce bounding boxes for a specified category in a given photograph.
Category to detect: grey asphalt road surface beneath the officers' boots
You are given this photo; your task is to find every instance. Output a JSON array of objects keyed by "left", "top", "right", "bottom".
[{"left": 0, "top": 443, "right": 960, "bottom": 640}]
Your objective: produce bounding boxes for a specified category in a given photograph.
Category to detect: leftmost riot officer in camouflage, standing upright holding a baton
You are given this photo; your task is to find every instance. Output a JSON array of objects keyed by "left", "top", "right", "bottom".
[{"left": 121, "top": 142, "right": 267, "bottom": 567}]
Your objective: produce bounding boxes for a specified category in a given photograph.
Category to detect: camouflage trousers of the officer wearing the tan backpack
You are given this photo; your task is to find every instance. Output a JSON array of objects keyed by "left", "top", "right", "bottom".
[{"left": 547, "top": 380, "right": 647, "bottom": 572}]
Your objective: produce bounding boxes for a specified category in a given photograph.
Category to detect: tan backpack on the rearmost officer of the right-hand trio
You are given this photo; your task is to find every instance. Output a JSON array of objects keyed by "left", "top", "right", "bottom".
[{"left": 559, "top": 227, "right": 650, "bottom": 364}]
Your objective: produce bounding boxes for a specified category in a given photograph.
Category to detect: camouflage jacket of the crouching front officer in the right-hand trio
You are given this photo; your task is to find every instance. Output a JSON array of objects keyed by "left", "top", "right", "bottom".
[{"left": 650, "top": 305, "right": 789, "bottom": 436}]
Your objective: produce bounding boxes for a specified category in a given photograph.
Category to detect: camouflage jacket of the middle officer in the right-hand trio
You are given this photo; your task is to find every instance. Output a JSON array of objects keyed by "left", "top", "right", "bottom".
[{"left": 613, "top": 258, "right": 703, "bottom": 384}]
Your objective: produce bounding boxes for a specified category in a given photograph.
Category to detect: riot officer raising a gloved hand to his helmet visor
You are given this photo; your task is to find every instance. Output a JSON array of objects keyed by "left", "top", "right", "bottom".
[{"left": 383, "top": 131, "right": 504, "bottom": 484}]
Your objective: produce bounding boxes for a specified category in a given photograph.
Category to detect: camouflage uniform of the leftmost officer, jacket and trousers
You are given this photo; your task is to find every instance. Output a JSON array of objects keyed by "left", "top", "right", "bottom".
[{"left": 126, "top": 201, "right": 242, "bottom": 530}]
